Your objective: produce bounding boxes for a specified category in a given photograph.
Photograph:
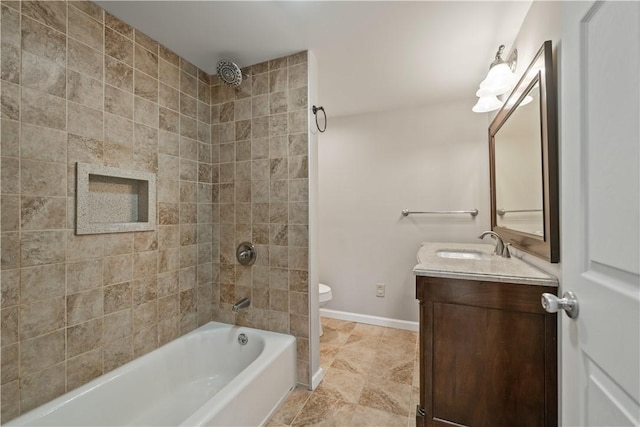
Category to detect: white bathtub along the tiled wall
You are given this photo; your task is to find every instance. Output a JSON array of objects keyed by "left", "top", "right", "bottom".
[{"left": 6, "top": 322, "right": 296, "bottom": 426}]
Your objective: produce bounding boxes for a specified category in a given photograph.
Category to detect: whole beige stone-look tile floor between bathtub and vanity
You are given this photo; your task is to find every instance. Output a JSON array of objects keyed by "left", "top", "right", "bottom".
[{"left": 267, "top": 318, "right": 418, "bottom": 427}]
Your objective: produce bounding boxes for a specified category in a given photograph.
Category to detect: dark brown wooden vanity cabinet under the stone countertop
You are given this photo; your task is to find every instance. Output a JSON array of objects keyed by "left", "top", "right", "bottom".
[{"left": 416, "top": 276, "right": 558, "bottom": 427}]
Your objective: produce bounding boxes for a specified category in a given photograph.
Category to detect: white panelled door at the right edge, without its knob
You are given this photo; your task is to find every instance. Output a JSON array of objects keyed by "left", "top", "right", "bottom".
[{"left": 559, "top": 1, "right": 640, "bottom": 426}]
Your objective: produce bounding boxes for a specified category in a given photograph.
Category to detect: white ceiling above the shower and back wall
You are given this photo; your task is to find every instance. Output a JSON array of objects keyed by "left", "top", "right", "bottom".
[{"left": 96, "top": 0, "right": 531, "bottom": 117}]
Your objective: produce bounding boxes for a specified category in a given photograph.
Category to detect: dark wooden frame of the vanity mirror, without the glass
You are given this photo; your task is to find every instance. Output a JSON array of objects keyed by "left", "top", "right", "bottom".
[{"left": 489, "top": 41, "right": 560, "bottom": 263}]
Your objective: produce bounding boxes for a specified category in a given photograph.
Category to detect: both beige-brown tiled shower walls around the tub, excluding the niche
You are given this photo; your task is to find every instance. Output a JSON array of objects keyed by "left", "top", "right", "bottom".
[{"left": 0, "top": 0, "right": 308, "bottom": 422}]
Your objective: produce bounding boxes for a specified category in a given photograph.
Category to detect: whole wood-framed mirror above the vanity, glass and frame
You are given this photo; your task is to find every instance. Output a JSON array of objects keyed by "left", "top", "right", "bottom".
[{"left": 489, "top": 41, "right": 560, "bottom": 262}]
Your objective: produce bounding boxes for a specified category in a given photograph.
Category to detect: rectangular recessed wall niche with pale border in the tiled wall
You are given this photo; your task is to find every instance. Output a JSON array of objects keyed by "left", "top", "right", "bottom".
[{"left": 76, "top": 163, "right": 156, "bottom": 234}]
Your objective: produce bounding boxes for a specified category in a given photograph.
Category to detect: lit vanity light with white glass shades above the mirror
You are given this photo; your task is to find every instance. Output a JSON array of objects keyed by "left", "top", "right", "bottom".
[{"left": 471, "top": 45, "right": 518, "bottom": 113}]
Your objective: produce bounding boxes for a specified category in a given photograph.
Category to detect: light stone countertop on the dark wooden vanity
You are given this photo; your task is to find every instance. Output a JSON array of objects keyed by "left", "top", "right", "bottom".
[{"left": 413, "top": 242, "right": 558, "bottom": 286}]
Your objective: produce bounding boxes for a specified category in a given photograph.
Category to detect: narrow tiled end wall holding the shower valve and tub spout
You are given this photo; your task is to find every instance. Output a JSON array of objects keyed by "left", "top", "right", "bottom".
[{"left": 211, "top": 52, "right": 310, "bottom": 384}]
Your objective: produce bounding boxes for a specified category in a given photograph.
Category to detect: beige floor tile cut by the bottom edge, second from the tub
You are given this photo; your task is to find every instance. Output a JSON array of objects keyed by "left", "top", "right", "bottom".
[{"left": 291, "top": 393, "right": 357, "bottom": 427}]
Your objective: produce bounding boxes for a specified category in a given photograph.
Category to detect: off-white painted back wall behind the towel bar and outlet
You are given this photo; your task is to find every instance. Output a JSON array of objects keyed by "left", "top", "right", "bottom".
[{"left": 318, "top": 101, "right": 490, "bottom": 321}]
